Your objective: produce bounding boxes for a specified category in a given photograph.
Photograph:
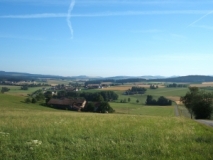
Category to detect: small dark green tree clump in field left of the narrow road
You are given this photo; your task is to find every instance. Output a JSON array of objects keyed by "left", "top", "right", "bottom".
[{"left": 146, "top": 95, "right": 172, "bottom": 106}]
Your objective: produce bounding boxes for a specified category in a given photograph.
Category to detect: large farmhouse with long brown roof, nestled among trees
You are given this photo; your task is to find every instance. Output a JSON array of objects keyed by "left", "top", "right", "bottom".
[{"left": 47, "top": 98, "right": 86, "bottom": 111}]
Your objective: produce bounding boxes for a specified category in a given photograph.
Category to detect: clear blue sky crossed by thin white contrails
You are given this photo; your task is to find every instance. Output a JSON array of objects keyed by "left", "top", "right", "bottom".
[{"left": 0, "top": 0, "right": 213, "bottom": 77}]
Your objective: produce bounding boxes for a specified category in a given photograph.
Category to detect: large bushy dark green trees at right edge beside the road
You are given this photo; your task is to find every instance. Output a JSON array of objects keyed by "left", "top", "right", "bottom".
[{"left": 180, "top": 87, "right": 213, "bottom": 119}]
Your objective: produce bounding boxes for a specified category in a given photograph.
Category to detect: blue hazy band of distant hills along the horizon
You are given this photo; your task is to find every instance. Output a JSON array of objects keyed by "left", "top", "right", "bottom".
[{"left": 0, "top": 71, "right": 213, "bottom": 83}]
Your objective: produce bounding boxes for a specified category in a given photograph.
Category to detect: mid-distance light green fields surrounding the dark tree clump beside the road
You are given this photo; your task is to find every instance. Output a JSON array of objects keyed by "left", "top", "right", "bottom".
[{"left": 105, "top": 88, "right": 188, "bottom": 116}]
